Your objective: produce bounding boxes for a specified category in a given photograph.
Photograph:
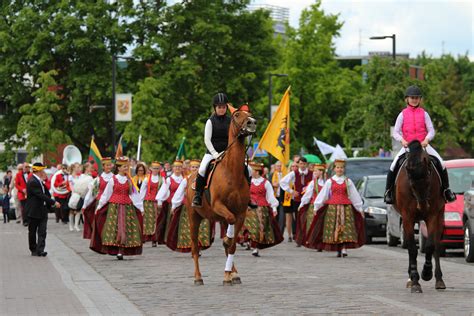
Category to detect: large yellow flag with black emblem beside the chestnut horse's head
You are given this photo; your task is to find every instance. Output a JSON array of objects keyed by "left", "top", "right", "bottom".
[{"left": 258, "top": 86, "right": 291, "bottom": 166}]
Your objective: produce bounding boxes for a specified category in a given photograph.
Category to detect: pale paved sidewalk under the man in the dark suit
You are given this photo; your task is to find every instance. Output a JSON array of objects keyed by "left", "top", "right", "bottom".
[{"left": 0, "top": 220, "right": 142, "bottom": 315}]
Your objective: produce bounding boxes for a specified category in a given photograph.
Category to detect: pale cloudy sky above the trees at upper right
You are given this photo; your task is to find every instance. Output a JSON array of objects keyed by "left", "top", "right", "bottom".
[{"left": 252, "top": 0, "right": 474, "bottom": 61}]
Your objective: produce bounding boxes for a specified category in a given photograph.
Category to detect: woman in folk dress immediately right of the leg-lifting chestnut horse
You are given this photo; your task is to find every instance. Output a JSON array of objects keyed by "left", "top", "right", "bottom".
[{"left": 239, "top": 162, "right": 283, "bottom": 257}]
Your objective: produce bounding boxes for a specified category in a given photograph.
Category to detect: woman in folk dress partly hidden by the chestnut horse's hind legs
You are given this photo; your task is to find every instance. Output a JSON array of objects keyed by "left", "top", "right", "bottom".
[{"left": 166, "top": 159, "right": 214, "bottom": 252}]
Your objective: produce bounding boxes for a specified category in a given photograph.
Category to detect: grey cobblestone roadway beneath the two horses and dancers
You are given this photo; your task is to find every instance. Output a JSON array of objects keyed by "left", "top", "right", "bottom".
[{"left": 43, "top": 217, "right": 474, "bottom": 315}]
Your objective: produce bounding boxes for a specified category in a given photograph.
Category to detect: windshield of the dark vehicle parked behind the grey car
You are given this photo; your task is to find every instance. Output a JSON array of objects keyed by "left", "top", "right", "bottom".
[{"left": 346, "top": 159, "right": 392, "bottom": 184}]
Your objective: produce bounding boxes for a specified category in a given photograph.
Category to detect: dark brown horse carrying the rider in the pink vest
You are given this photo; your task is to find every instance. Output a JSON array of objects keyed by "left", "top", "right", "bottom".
[{"left": 394, "top": 140, "right": 446, "bottom": 293}]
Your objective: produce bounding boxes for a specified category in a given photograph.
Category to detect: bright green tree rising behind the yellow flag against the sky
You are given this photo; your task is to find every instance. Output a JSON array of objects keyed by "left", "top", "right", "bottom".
[{"left": 276, "top": 1, "right": 361, "bottom": 153}]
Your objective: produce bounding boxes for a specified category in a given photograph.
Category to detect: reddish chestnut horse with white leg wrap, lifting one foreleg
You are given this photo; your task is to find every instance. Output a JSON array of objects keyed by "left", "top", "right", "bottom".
[{"left": 185, "top": 105, "right": 257, "bottom": 285}]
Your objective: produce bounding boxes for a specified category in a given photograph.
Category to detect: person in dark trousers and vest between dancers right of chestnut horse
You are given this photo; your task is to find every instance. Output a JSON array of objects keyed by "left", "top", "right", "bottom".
[{"left": 280, "top": 157, "right": 313, "bottom": 246}]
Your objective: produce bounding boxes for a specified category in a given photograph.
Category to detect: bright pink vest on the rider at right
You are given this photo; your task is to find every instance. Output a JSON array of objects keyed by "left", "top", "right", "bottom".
[{"left": 402, "top": 106, "right": 428, "bottom": 142}]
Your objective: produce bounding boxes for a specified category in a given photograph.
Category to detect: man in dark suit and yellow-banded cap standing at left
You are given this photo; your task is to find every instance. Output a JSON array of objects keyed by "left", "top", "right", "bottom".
[{"left": 25, "top": 162, "right": 60, "bottom": 257}]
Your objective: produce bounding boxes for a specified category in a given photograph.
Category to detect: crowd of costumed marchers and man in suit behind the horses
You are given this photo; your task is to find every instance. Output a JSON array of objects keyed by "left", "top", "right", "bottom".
[{"left": 2, "top": 152, "right": 362, "bottom": 260}]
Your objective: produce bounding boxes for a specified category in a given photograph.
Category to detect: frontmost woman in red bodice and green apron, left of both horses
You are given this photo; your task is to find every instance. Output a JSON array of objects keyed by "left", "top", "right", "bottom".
[{"left": 90, "top": 157, "right": 143, "bottom": 260}]
